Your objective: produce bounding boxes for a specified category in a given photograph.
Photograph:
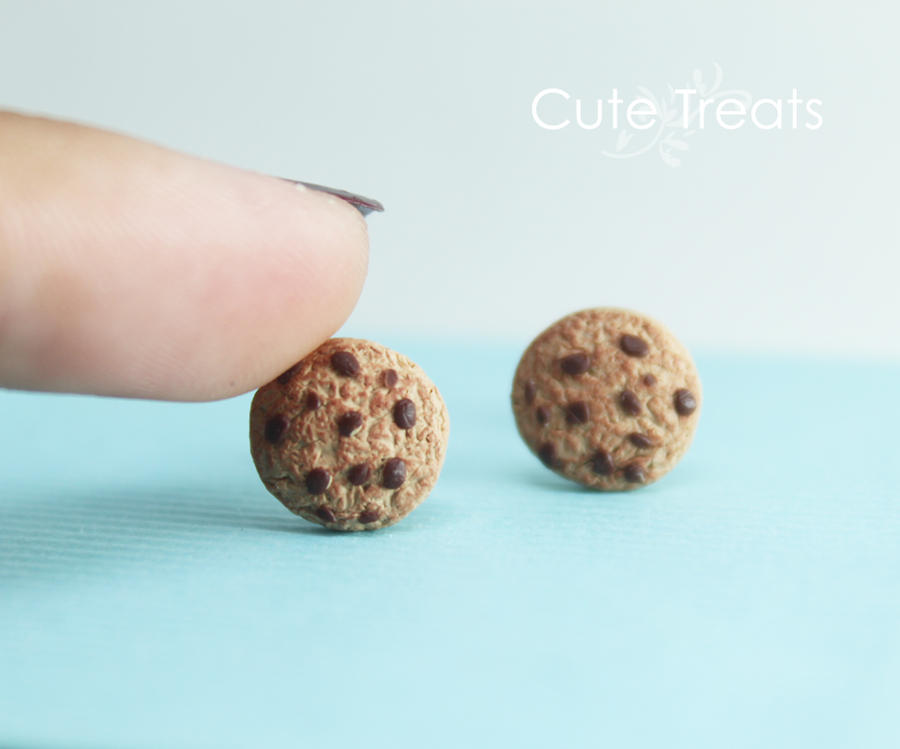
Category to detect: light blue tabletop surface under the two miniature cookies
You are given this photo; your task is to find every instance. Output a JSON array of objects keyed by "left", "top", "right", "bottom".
[{"left": 0, "top": 341, "right": 900, "bottom": 747}]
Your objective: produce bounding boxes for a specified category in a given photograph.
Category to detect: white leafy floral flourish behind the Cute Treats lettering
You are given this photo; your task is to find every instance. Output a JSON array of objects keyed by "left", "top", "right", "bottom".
[{"left": 602, "top": 62, "right": 753, "bottom": 168}]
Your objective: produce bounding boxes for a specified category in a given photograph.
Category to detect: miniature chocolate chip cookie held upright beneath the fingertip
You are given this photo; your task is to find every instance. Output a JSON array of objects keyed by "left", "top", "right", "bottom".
[{"left": 250, "top": 338, "right": 450, "bottom": 531}]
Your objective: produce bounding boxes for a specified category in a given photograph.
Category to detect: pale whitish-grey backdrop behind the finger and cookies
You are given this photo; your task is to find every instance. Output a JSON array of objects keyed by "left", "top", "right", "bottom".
[{"left": 0, "top": 0, "right": 900, "bottom": 358}]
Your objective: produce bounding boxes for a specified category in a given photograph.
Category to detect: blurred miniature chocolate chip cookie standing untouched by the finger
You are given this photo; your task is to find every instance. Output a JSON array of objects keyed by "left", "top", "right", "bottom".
[{"left": 512, "top": 308, "right": 701, "bottom": 490}]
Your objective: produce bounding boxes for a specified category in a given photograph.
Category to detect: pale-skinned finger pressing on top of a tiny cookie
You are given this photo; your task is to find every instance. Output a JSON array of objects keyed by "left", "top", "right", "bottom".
[{"left": 0, "top": 112, "right": 368, "bottom": 401}]
